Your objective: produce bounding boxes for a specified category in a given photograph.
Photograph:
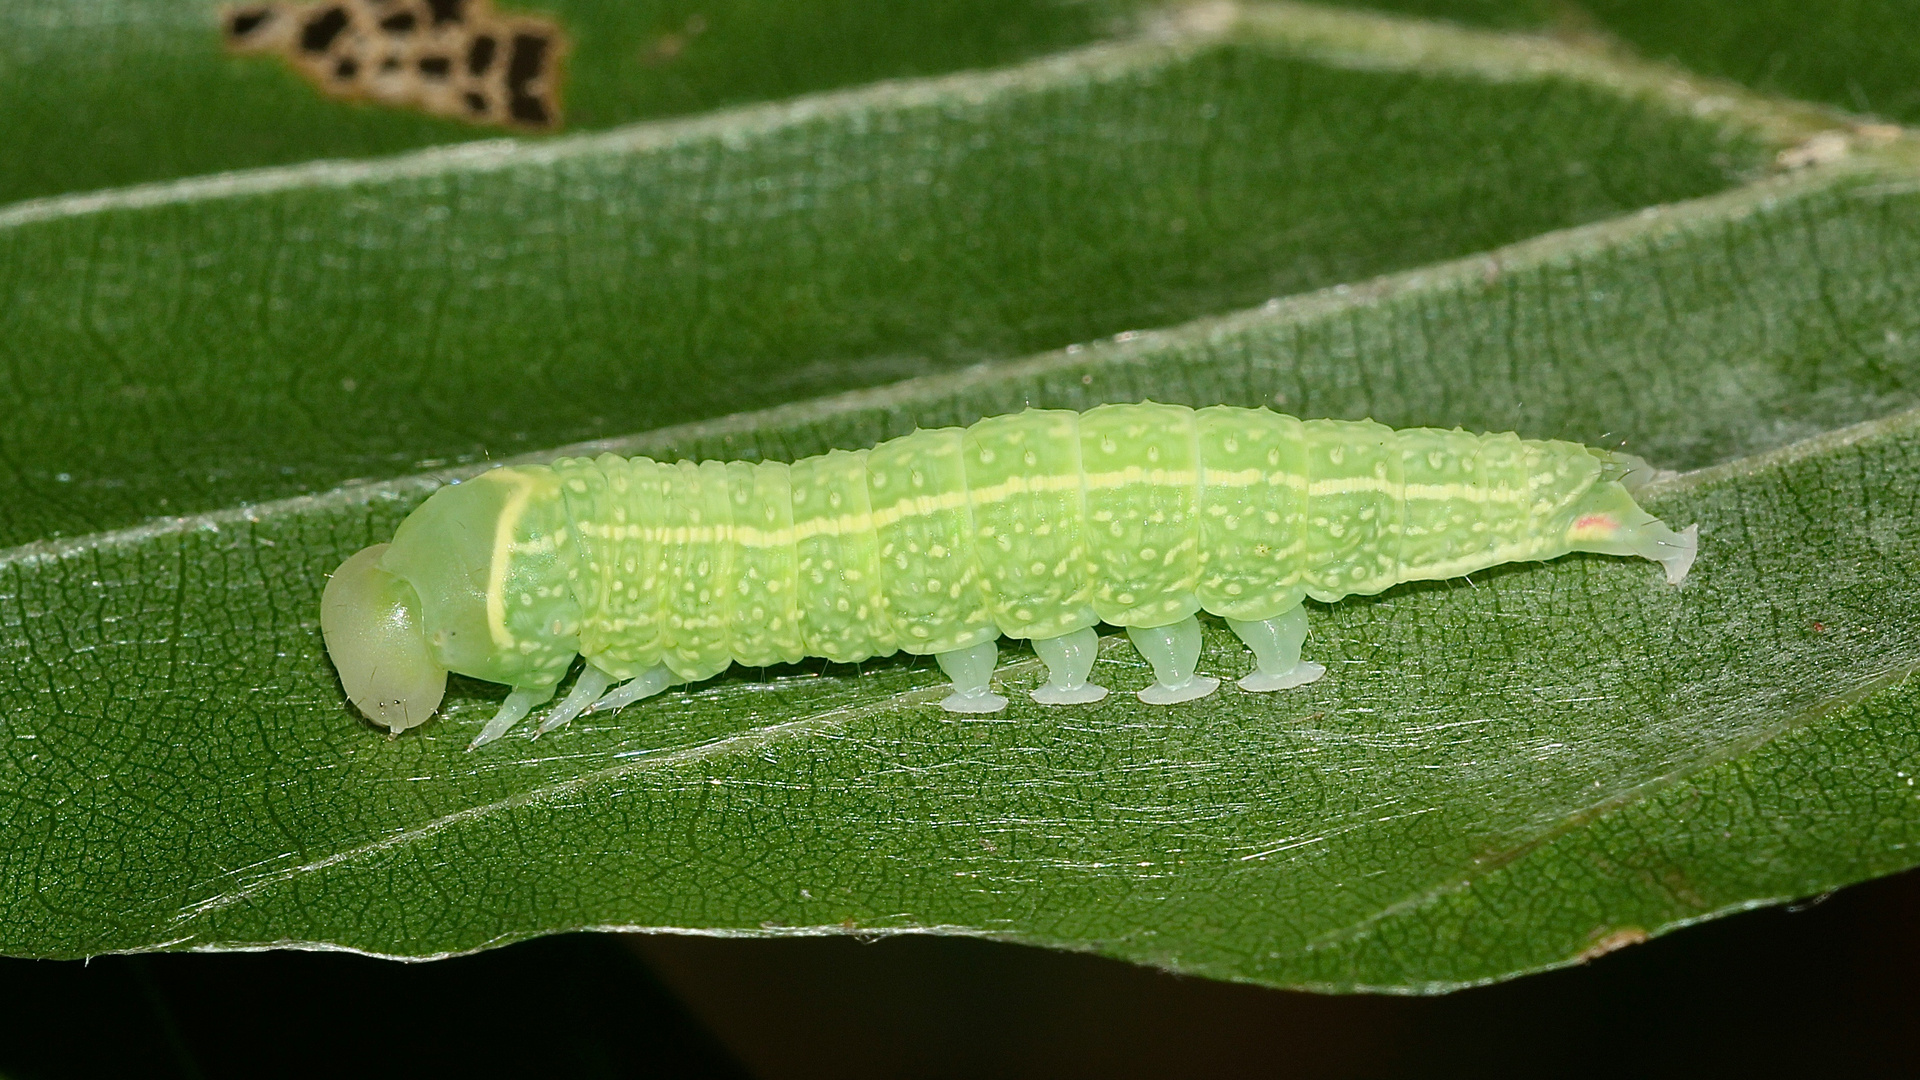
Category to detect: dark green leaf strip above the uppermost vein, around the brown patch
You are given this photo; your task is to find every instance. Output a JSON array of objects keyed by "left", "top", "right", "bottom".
[{"left": 0, "top": 0, "right": 1135, "bottom": 202}]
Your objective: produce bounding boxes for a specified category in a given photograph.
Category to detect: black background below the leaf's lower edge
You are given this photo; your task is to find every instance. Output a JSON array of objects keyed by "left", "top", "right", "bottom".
[{"left": 0, "top": 857, "right": 1920, "bottom": 1080}]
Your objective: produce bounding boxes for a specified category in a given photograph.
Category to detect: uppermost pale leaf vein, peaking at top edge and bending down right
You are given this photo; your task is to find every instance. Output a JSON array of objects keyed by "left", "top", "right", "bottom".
[{"left": 0, "top": 0, "right": 1858, "bottom": 229}]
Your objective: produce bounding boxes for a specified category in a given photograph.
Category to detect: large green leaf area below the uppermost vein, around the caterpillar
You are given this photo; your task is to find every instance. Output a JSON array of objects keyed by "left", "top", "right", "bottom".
[{"left": 0, "top": 0, "right": 1920, "bottom": 990}]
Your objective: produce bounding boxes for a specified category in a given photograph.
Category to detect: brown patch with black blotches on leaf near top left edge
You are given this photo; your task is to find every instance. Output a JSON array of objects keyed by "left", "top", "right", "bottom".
[{"left": 221, "top": 0, "right": 568, "bottom": 131}]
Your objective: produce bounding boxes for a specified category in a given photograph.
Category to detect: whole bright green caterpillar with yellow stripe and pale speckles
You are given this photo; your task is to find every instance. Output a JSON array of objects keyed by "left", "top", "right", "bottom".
[{"left": 321, "top": 402, "right": 1697, "bottom": 749}]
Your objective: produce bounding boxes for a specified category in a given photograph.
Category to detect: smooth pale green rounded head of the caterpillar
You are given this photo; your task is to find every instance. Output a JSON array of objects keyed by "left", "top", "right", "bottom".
[{"left": 321, "top": 544, "right": 447, "bottom": 734}]
